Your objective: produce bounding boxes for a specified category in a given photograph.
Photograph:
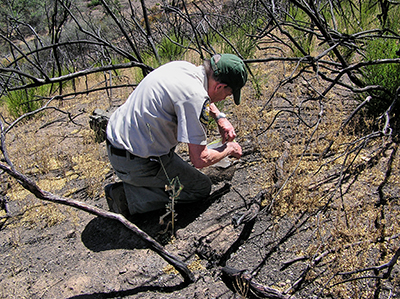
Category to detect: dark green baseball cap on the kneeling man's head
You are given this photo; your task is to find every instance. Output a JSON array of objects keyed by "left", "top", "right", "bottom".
[{"left": 211, "top": 54, "right": 247, "bottom": 105}]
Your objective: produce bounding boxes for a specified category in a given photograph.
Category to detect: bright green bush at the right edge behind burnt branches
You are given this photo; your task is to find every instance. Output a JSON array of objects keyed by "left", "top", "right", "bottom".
[{"left": 363, "top": 38, "right": 400, "bottom": 115}]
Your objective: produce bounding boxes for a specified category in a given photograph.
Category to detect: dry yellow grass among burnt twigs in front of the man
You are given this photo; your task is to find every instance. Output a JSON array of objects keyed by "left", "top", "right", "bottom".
[{"left": 228, "top": 54, "right": 400, "bottom": 298}]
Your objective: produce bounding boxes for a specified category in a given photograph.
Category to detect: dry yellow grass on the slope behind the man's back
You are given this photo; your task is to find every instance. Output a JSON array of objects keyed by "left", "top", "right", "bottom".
[{"left": 1, "top": 72, "right": 133, "bottom": 226}]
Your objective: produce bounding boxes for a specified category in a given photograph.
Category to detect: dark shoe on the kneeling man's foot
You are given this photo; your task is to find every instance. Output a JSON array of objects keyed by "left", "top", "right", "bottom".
[{"left": 104, "top": 182, "right": 129, "bottom": 217}]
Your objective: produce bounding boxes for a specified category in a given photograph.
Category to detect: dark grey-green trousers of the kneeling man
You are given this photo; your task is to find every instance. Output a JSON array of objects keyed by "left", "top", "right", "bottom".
[{"left": 107, "top": 145, "right": 211, "bottom": 214}]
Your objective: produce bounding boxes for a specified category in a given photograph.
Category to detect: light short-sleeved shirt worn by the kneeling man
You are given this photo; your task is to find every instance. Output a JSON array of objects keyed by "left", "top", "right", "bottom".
[{"left": 107, "top": 61, "right": 210, "bottom": 157}]
